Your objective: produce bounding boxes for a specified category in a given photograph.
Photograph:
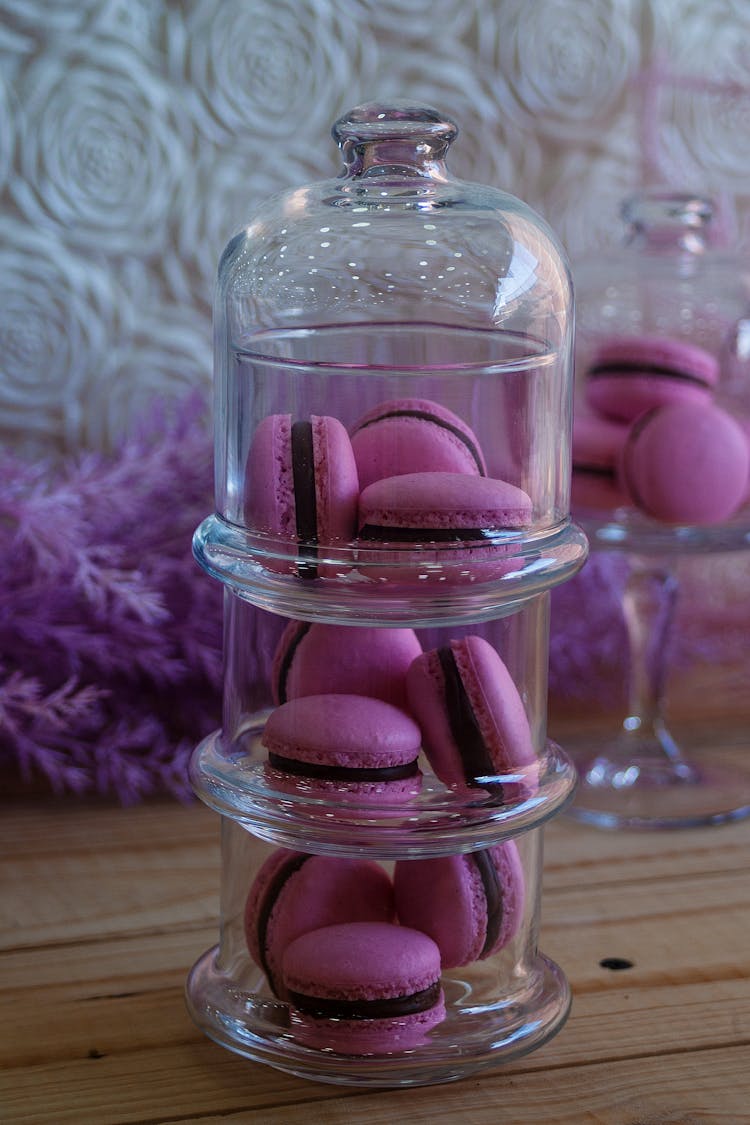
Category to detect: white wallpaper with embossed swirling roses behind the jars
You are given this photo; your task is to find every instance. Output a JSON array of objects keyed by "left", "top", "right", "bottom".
[{"left": 0, "top": 0, "right": 750, "bottom": 451}]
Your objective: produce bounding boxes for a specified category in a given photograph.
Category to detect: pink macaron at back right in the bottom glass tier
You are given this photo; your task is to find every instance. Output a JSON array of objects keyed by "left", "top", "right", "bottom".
[{"left": 394, "top": 840, "right": 525, "bottom": 969}]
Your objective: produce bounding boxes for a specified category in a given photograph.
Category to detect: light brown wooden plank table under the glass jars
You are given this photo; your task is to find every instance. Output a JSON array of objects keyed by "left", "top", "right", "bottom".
[{"left": 0, "top": 798, "right": 750, "bottom": 1125}]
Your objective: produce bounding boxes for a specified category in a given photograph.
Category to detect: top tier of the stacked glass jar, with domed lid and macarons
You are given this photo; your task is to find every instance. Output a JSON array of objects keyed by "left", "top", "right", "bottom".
[{"left": 196, "top": 105, "right": 585, "bottom": 620}]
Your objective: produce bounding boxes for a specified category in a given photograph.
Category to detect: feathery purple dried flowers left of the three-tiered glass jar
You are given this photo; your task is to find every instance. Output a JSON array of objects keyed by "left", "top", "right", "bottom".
[{"left": 0, "top": 395, "right": 222, "bottom": 802}]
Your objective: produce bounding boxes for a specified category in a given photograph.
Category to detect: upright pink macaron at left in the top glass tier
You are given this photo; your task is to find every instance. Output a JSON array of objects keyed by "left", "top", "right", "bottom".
[{"left": 245, "top": 414, "right": 360, "bottom": 578}]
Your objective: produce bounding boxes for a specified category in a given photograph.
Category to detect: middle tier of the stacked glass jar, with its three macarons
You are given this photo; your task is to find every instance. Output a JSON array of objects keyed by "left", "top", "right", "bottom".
[{"left": 191, "top": 591, "right": 573, "bottom": 854}]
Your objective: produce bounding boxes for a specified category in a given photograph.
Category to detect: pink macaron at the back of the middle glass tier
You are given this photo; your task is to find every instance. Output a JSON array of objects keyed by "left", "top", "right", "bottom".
[{"left": 271, "top": 621, "right": 422, "bottom": 708}]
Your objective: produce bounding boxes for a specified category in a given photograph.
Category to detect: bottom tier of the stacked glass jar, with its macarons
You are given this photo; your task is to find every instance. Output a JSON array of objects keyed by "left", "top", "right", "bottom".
[{"left": 188, "top": 818, "right": 570, "bottom": 1086}]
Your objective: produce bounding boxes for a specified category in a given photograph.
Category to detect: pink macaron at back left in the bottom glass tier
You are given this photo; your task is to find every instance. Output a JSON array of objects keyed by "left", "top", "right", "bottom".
[{"left": 244, "top": 848, "right": 395, "bottom": 998}]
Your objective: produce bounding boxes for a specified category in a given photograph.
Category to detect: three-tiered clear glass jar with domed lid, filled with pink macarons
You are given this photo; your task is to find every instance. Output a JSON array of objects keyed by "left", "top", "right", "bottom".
[{"left": 187, "top": 104, "right": 587, "bottom": 1086}]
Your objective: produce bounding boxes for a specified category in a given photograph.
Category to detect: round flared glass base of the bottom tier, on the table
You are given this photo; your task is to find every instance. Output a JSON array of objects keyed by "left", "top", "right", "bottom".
[{"left": 186, "top": 948, "right": 570, "bottom": 1087}]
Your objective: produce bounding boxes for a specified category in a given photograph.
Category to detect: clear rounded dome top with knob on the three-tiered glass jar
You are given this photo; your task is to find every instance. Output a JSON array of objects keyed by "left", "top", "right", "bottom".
[{"left": 218, "top": 102, "right": 571, "bottom": 358}]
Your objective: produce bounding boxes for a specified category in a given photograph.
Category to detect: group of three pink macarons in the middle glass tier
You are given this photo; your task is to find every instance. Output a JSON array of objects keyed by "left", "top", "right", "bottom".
[{"left": 261, "top": 621, "right": 536, "bottom": 807}]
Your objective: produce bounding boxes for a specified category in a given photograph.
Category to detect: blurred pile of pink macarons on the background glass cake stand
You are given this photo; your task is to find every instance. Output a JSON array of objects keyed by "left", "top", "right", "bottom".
[{"left": 572, "top": 335, "right": 750, "bottom": 525}]
